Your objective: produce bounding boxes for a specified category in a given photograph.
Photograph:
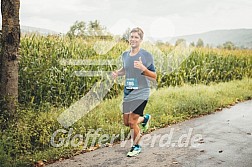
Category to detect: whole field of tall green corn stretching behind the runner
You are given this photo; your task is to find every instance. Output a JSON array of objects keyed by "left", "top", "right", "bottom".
[{"left": 19, "top": 35, "right": 252, "bottom": 106}]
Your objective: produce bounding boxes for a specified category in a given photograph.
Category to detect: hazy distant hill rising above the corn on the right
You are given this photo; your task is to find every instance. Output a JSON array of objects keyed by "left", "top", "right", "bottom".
[{"left": 169, "top": 29, "right": 252, "bottom": 49}]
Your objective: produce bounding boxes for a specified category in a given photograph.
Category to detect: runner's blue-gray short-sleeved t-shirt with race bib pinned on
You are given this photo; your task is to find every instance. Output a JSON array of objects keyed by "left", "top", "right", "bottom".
[{"left": 122, "top": 49, "right": 155, "bottom": 102}]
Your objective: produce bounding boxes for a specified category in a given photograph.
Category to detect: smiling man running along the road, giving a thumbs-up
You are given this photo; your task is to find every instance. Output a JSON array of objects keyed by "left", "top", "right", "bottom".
[{"left": 112, "top": 27, "right": 157, "bottom": 157}]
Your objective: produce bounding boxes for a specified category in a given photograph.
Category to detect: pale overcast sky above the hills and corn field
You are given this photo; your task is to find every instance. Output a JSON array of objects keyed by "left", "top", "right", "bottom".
[{"left": 9, "top": 0, "right": 252, "bottom": 37}]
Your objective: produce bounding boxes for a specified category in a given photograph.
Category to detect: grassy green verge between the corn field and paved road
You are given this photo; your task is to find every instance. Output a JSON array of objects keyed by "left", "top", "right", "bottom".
[{"left": 0, "top": 79, "right": 252, "bottom": 166}]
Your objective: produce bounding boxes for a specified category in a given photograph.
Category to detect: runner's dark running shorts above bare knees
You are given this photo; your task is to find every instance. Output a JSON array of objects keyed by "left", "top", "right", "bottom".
[{"left": 123, "top": 100, "right": 148, "bottom": 116}]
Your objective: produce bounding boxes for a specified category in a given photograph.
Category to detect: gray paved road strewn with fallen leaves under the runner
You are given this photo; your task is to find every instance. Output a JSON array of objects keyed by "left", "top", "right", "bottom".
[{"left": 48, "top": 100, "right": 252, "bottom": 167}]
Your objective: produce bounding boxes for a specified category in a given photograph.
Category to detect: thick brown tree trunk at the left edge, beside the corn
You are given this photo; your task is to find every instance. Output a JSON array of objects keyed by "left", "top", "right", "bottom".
[{"left": 0, "top": 0, "right": 20, "bottom": 119}]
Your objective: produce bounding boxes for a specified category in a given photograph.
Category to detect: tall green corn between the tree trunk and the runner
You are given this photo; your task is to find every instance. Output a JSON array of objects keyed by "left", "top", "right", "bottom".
[{"left": 19, "top": 35, "right": 127, "bottom": 106}]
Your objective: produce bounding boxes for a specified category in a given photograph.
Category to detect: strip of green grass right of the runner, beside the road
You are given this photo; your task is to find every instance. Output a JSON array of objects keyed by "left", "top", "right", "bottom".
[{"left": 146, "top": 79, "right": 252, "bottom": 128}]
